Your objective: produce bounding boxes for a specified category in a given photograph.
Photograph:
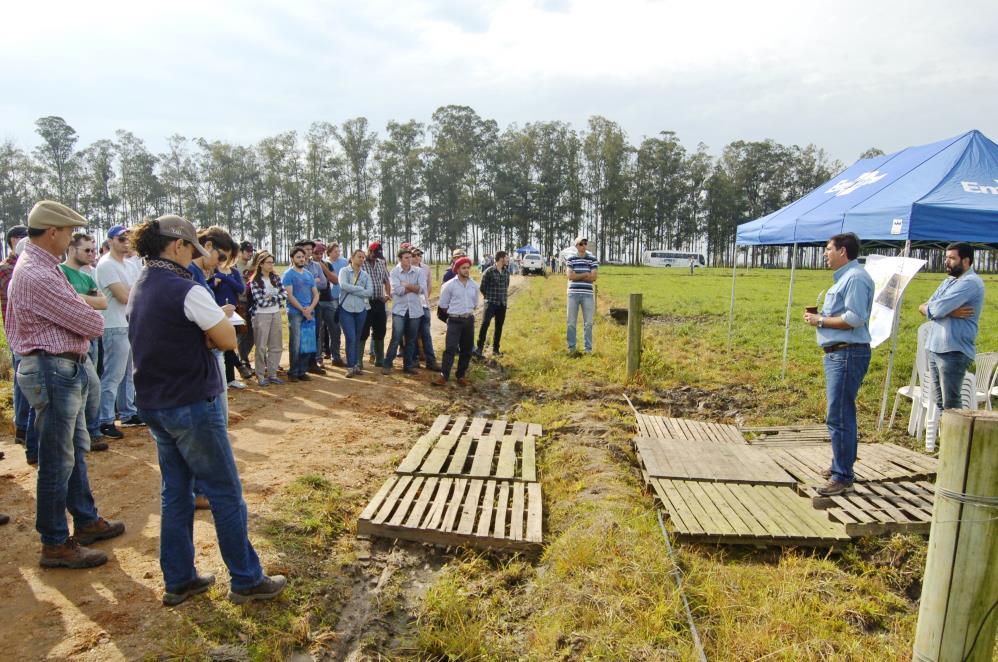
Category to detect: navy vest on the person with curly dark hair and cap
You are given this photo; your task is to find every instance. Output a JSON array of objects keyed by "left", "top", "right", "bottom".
[{"left": 128, "top": 265, "right": 223, "bottom": 409}]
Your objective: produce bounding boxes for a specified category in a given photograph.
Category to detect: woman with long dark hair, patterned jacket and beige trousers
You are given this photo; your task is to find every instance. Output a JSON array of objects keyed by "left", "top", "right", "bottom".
[{"left": 248, "top": 251, "right": 288, "bottom": 386}]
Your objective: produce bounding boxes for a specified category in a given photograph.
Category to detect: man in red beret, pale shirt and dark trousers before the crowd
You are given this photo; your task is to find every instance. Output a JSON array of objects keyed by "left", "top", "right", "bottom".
[{"left": 431, "top": 257, "right": 478, "bottom": 386}]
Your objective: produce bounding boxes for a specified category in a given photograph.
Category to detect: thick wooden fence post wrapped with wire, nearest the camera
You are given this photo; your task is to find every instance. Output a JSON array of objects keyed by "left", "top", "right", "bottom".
[{"left": 913, "top": 410, "right": 998, "bottom": 662}]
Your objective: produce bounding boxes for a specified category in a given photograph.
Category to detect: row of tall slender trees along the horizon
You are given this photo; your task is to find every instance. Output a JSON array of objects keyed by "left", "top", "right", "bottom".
[{"left": 0, "top": 106, "right": 864, "bottom": 265}]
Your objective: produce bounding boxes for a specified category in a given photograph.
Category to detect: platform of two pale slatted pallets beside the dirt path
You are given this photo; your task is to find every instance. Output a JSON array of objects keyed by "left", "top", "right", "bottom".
[{"left": 357, "top": 416, "right": 543, "bottom": 551}]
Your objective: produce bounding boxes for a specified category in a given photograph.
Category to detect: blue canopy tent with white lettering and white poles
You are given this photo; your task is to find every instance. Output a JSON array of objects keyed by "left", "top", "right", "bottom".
[{"left": 728, "top": 130, "right": 998, "bottom": 423}]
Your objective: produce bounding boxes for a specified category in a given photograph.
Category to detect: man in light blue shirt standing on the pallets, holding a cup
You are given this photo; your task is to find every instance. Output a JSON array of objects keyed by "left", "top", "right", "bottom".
[{"left": 804, "top": 232, "right": 874, "bottom": 496}]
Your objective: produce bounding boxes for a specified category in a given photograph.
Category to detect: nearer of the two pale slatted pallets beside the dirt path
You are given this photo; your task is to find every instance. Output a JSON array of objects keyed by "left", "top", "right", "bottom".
[{"left": 357, "top": 475, "right": 542, "bottom": 552}]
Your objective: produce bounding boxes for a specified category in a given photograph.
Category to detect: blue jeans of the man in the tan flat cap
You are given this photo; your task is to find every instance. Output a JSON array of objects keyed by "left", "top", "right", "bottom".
[{"left": 16, "top": 354, "right": 97, "bottom": 545}]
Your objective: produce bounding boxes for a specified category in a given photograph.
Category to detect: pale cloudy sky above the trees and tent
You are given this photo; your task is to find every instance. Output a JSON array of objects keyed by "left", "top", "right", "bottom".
[{"left": 0, "top": 0, "right": 998, "bottom": 163}]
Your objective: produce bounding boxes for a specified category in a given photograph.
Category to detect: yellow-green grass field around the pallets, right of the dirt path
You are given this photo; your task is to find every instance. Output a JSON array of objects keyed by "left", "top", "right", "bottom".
[{"left": 407, "top": 267, "right": 998, "bottom": 661}]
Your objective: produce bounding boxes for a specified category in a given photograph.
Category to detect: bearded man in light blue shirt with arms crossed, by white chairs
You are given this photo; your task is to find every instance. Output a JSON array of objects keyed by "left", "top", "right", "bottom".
[{"left": 918, "top": 243, "right": 987, "bottom": 409}]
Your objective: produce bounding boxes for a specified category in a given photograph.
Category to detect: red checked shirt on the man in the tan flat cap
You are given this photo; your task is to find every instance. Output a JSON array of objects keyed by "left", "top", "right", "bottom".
[{"left": 4, "top": 242, "right": 104, "bottom": 355}]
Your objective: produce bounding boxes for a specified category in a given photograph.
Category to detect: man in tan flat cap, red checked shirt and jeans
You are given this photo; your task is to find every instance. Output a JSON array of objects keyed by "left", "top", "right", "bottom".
[{"left": 6, "top": 200, "right": 125, "bottom": 568}]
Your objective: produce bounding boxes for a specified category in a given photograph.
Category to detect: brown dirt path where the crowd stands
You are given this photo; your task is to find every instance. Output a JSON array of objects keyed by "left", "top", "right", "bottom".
[{"left": 0, "top": 277, "right": 526, "bottom": 660}]
